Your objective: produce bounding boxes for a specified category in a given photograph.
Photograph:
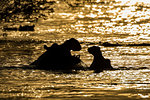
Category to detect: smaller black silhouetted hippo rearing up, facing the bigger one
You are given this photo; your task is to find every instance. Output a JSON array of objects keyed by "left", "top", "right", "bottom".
[{"left": 88, "top": 46, "right": 113, "bottom": 73}]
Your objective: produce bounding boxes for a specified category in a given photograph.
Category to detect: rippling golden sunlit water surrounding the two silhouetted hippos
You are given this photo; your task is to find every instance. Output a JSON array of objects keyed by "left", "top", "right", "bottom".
[{"left": 0, "top": 0, "right": 150, "bottom": 100}]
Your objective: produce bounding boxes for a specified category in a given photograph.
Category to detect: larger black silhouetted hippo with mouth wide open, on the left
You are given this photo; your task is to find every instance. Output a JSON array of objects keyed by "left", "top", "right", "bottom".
[{"left": 31, "top": 38, "right": 81, "bottom": 70}]
